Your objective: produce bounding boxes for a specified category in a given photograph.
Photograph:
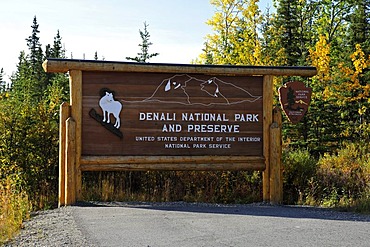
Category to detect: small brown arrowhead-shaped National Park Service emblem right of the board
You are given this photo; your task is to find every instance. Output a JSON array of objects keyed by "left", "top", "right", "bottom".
[{"left": 279, "top": 81, "right": 312, "bottom": 124}]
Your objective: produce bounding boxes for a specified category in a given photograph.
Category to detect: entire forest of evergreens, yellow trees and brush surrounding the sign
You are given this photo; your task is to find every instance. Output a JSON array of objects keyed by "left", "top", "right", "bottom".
[{"left": 0, "top": 0, "right": 370, "bottom": 243}]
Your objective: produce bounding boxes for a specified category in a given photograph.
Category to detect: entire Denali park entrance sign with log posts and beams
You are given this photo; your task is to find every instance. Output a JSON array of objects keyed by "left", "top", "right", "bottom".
[{"left": 43, "top": 59, "right": 316, "bottom": 206}]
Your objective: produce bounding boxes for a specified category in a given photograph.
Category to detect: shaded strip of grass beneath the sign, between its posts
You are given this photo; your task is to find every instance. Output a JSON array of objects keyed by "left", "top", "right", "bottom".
[{"left": 82, "top": 171, "right": 262, "bottom": 203}]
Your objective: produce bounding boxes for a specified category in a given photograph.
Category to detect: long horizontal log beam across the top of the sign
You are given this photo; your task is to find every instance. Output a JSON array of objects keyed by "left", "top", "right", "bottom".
[{"left": 42, "top": 58, "right": 317, "bottom": 77}]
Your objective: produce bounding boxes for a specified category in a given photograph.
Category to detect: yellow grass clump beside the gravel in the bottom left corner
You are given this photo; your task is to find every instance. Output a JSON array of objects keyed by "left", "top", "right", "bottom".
[{"left": 0, "top": 178, "right": 32, "bottom": 245}]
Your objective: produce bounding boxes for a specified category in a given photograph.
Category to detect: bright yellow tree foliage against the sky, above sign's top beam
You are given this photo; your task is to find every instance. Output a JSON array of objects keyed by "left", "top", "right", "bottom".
[{"left": 196, "top": 0, "right": 263, "bottom": 65}]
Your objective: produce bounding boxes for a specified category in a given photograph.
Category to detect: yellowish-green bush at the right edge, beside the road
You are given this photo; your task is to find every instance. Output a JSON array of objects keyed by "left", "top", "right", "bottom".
[{"left": 310, "top": 143, "right": 370, "bottom": 207}]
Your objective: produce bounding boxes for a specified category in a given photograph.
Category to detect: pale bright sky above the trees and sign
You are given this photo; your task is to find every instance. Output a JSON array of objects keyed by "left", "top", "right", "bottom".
[{"left": 0, "top": 0, "right": 273, "bottom": 80}]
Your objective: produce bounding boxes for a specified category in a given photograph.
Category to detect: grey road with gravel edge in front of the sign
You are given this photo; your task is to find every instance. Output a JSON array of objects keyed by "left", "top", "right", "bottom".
[{"left": 5, "top": 202, "right": 370, "bottom": 247}]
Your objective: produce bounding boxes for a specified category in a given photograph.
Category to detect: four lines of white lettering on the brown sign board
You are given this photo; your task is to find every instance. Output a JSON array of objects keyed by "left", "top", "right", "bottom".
[{"left": 135, "top": 112, "right": 262, "bottom": 150}]
